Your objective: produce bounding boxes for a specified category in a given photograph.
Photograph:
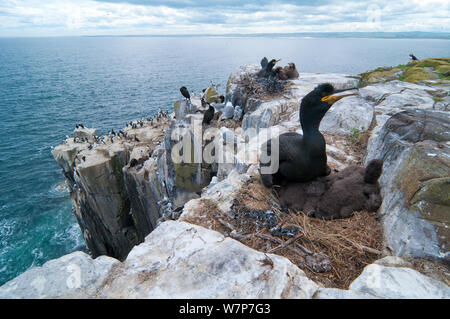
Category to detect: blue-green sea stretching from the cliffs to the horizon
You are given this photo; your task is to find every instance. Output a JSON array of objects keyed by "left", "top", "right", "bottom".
[{"left": 0, "top": 37, "right": 450, "bottom": 285}]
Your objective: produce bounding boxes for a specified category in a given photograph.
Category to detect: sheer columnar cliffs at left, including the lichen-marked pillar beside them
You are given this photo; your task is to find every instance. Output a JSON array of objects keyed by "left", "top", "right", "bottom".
[{"left": 52, "top": 98, "right": 218, "bottom": 260}]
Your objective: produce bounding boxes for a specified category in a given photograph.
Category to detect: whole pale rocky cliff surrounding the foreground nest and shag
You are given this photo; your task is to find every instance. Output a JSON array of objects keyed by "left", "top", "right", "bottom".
[{"left": 0, "top": 59, "right": 450, "bottom": 298}]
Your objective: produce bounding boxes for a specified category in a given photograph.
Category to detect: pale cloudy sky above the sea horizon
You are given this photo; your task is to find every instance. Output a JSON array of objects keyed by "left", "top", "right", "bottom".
[{"left": 0, "top": 0, "right": 450, "bottom": 37}]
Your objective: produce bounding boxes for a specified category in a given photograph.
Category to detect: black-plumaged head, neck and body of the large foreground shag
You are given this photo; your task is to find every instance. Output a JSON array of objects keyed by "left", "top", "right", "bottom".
[{"left": 260, "top": 83, "right": 334, "bottom": 187}]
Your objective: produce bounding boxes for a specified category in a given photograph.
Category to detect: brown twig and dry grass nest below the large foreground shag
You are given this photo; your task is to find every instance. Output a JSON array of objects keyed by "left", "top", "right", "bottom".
[{"left": 182, "top": 180, "right": 382, "bottom": 289}]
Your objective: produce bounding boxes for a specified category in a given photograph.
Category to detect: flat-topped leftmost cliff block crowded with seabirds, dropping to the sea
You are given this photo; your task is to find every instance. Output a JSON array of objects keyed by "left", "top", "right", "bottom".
[{"left": 52, "top": 118, "right": 172, "bottom": 260}]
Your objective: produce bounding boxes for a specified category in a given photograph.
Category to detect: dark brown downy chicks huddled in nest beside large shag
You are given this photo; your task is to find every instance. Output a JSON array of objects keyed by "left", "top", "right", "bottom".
[{"left": 279, "top": 160, "right": 383, "bottom": 219}]
